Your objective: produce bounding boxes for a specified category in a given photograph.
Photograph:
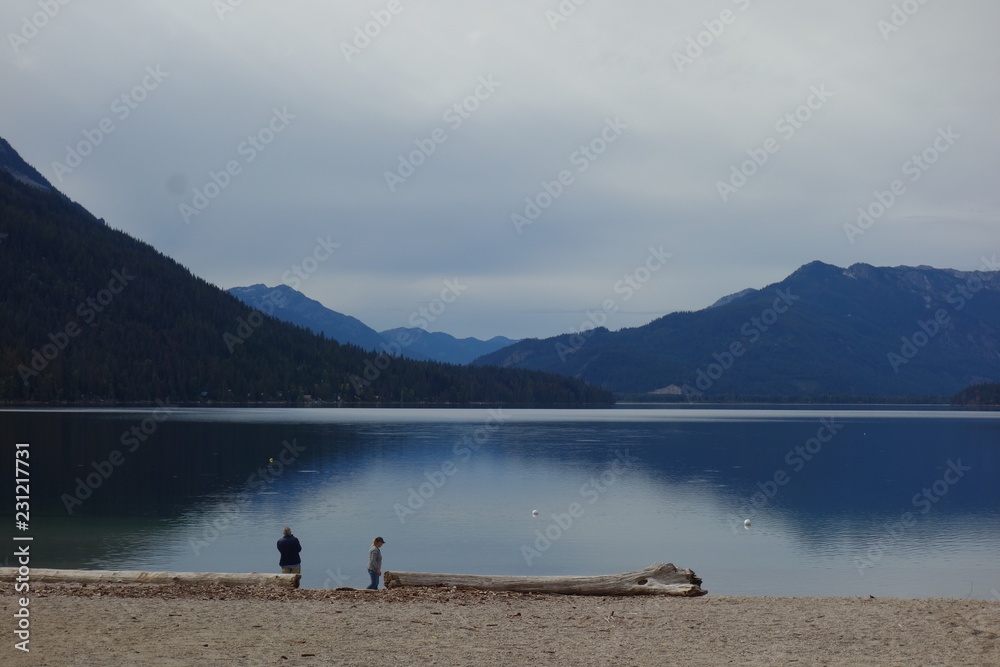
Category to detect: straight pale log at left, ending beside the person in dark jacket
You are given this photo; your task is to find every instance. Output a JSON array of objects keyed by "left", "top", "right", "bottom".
[{"left": 0, "top": 567, "right": 302, "bottom": 588}]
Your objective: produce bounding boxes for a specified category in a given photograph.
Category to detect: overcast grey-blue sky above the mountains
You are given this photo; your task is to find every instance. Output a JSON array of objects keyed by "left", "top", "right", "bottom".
[{"left": 0, "top": 0, "right": 1000, "bottom": 338}]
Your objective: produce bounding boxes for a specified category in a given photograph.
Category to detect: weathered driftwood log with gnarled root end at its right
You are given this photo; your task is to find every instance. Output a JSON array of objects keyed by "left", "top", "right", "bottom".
[{"left": 385, "top": 563, "right": 708, "bottom": 597}]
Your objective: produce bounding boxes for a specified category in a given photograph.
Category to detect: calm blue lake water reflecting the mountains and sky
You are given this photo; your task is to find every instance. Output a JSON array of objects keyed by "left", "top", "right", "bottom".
[{"left": 0, "top": 406, "right": 1000, "bottom": 599}]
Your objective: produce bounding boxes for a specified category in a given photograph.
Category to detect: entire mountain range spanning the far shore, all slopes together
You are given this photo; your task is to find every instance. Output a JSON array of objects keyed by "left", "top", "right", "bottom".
[{"left": 0, "top": 132, "right": 1000, "bottom": 404}]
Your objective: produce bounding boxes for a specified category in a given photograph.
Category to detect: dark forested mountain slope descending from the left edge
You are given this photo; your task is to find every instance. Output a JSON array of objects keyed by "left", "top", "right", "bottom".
[{"left": 0, "top": 141, "right": 613, "bottom": 405}]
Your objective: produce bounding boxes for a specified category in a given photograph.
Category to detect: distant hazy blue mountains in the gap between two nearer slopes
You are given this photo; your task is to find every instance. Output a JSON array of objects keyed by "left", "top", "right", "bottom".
[{"left": 227, "top": 284, "right": 517, "bottom": 364}]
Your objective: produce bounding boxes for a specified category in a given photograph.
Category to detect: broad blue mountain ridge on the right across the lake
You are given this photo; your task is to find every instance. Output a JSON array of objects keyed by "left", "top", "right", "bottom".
[{"left": 474, "top": 256, "right": 1000, "bottom": 400}]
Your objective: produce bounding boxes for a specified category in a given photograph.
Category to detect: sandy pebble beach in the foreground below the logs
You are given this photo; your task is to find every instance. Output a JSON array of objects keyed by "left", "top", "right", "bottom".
[{"left": 0, "top": 584, "right": 1000, "bottom": 666}]
